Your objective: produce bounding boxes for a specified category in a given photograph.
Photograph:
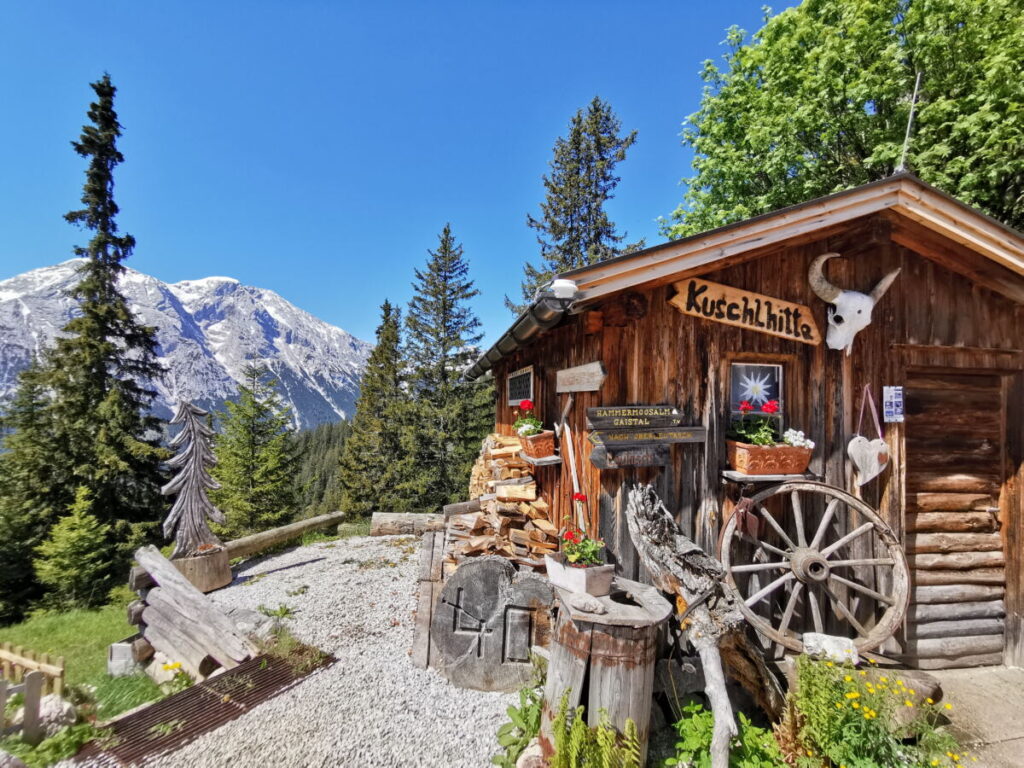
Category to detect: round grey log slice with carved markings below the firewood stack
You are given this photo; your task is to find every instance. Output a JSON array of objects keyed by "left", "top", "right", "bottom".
[{"left": 430, "top": 556, "right": 554, "bottom": 691}]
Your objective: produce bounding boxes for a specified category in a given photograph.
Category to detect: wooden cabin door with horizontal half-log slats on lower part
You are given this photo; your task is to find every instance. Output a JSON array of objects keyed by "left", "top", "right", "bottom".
[{"left": 904, "top": 372, "right": 1008, "bottom": 669}]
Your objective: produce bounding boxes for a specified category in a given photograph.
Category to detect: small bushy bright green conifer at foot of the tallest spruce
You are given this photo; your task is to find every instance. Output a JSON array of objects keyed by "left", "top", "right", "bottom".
[{"left": 34, "top": 486, "right": 113, "bottom": 609}]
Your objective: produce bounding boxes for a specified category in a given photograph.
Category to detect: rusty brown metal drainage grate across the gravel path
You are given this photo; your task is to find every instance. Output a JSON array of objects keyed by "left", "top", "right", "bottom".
[{"left": 76, "top": 655, "right": 336, "bottom": 766}]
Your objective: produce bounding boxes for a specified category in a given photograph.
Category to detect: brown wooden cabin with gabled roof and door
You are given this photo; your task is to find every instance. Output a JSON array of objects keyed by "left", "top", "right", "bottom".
[{"left": 466, "top": 174, "right": 1024, "bottom": 669}]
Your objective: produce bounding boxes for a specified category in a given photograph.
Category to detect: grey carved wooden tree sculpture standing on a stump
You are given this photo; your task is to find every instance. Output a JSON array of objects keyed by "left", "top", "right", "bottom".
[{"left": 161, "top": 402, "right": 224, "bottom": 558}]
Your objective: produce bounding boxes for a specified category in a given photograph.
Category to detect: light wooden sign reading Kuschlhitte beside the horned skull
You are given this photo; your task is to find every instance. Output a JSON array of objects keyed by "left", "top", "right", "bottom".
[{"left": 669, "top": 278, "right": 821, "bottom": 344}]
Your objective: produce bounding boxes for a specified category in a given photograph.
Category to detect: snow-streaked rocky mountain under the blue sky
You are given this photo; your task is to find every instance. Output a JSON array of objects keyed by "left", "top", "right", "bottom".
[{"left": 0, "top": 259, "right": 372, "bottom": 428}]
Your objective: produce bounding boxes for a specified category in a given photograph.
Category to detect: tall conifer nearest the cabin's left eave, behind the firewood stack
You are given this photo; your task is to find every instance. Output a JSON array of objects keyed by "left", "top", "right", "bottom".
[{"left": 400, "top": 224, "right": 494, "bottom": 511}]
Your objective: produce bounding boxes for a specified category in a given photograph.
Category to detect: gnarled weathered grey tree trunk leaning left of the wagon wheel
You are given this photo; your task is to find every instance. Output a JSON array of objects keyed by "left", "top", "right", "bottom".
[{"left": 626, "top": 485, "right": 782, "bottom": 768}]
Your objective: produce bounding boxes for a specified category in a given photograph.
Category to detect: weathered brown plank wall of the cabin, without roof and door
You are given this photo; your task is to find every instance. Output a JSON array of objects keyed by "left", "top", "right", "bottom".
[{"left": 495, "top": 216, "right": 1024, "bottom": 658}]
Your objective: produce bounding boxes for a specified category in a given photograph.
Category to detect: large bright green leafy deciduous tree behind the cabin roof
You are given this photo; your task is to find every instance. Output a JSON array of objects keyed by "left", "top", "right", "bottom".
[{"left": 665, "top": 0, "right": 1024, "bottom": 238}]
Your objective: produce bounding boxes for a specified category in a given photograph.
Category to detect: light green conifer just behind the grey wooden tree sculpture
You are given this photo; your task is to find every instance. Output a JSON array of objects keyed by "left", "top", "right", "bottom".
[{"left": 210, "top": 364, "right": 296, "bottom": 538}]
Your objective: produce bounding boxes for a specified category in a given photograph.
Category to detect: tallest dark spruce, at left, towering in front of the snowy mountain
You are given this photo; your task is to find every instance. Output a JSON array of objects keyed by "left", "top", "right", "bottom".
[{"left": 44, "top": 75, "right": 166, "bottom": 556}]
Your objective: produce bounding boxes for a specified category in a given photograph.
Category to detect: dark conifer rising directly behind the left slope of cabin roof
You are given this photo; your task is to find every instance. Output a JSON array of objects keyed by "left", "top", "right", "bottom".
[{"left": 505, "top": 96, "right": 643, "bottom": 313}]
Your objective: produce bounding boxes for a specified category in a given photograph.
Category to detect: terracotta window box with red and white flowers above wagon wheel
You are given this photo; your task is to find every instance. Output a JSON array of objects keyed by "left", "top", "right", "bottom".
[{"left": 726, "top": 400, "right": 814, "bottom": 475}]
